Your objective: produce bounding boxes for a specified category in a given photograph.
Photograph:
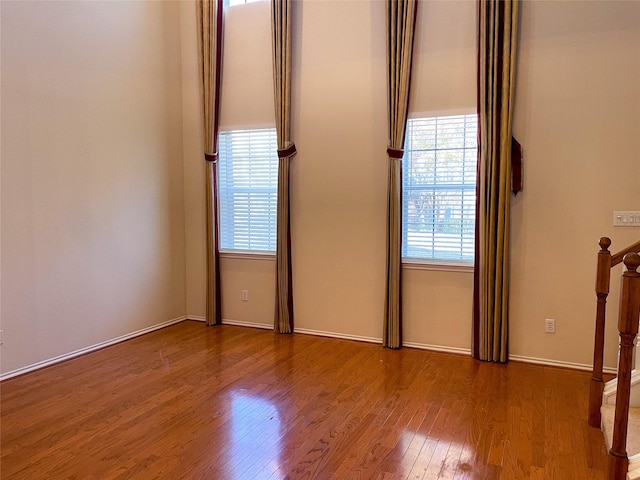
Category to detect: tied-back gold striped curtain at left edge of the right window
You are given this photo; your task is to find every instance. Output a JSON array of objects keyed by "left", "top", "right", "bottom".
[{"left": 382, "top": 0, "right": 418, "bottom": 348}]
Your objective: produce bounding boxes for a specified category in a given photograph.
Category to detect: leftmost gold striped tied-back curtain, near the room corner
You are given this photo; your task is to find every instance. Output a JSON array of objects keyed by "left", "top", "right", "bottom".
[{"left": 196, "top": 0, "right": 224, "bottom": 325}]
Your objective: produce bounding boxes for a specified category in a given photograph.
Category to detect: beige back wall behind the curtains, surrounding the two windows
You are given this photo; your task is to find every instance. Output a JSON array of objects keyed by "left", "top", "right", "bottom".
[{"left": 182, "top": 0, "right": 640, "bottom": 366}]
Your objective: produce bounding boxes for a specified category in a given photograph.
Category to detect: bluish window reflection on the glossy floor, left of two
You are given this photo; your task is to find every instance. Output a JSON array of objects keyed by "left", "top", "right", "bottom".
[{"left": 229, "top": 391, "right": 284, "bottom": 480}]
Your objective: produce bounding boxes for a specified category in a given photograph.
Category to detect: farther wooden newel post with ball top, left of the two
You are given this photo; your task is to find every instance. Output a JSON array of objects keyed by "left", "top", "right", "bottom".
[{"left": 589, "top": 237, "right": 611, "bottom": 428}]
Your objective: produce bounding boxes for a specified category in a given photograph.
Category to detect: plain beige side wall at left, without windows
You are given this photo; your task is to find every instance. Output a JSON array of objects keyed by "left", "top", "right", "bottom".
[{"left": 1, "top": 1, "right": 186, "bottom": 372}]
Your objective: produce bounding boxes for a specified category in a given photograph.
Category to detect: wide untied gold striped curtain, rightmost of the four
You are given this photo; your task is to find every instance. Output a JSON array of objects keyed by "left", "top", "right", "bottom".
[{"left": 473, "top": 0, "right": 518, "bottom": 362}]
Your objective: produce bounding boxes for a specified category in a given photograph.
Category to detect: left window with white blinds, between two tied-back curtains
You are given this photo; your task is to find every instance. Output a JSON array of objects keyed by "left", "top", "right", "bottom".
[{"left": 218, "top": 128, "right": 278, "bottom": 252}]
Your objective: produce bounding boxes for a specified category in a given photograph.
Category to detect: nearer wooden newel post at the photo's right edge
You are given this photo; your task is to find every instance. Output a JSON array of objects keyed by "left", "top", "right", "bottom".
[{"left": 608, "top": 253, "right": 640, "bottom": 480}]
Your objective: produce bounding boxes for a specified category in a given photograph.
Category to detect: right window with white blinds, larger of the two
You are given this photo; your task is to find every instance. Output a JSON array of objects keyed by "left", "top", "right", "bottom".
[{"left": 402, "top": 114, "right": 478, "bottom": 262}]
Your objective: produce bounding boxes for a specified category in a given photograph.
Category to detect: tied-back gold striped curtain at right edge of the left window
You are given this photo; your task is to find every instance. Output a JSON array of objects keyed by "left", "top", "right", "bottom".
[{"left": 271, "top": 0, "right": 296, "bottom": 333}]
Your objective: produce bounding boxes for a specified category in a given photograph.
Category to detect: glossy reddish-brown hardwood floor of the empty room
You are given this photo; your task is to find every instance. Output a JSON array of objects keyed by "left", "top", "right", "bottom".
[{"left": 0, "top": 321, "right": 606, "bottom": 480}]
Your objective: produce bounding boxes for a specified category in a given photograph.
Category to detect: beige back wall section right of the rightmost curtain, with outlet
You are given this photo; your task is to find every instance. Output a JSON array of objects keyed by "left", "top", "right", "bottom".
[{"left": 510, "top": 1, "right": 640, "bottom": 366}]
